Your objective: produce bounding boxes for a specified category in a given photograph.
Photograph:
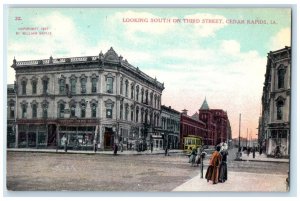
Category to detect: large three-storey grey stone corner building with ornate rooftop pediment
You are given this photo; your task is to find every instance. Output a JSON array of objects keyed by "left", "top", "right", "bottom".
[{"left": 12, "top": 48, "right": 164, "bottom": 149}]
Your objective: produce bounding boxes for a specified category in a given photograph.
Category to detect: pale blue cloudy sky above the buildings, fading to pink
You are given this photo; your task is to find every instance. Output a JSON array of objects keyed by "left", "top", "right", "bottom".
[{"left": 7, "top": 8, "right": 291, "bottom": 136}]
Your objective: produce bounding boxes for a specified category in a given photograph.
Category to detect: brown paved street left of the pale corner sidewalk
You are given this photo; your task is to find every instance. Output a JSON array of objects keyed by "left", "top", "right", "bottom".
[{"left": 7, "top": 152, "right": 198, "bottom": 191}]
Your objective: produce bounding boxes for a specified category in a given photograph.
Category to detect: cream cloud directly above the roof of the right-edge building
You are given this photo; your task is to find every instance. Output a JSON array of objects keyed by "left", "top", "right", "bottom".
[{"left": 270, "top": 28, "right": 291, "bottom": 51}]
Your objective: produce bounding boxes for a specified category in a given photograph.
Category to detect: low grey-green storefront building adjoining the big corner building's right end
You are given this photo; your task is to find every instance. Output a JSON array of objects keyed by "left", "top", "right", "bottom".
[{"left": 161, "top": 105, "right": 180, "bottom": 149}]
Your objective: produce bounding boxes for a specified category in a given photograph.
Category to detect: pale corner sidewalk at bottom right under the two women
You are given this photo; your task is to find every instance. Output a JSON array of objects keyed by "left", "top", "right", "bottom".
[{"left": 173, "top": 171, "right": 287, "bottom": 192}]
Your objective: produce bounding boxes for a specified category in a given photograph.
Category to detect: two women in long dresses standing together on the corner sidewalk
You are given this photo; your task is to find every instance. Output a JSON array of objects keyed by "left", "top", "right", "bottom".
[{"left": 205, "top": 143, "right": 228, "bottom": 184}]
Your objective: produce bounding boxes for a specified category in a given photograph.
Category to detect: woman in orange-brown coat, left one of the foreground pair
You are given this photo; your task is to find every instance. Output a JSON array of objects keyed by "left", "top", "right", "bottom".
[{"left": 205, "top": 146, "right": 221, "bottom": 184}]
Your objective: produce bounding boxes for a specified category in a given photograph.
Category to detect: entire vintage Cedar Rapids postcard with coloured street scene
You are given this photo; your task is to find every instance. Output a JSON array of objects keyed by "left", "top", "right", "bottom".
[{"left": 5, "top": 5, "right": 296, "bottom": 193}]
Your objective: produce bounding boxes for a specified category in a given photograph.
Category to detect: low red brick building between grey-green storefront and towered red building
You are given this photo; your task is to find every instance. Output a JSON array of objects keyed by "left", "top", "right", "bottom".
[{"left": 180, "top": 110, "right": 207, "bottom": 149}]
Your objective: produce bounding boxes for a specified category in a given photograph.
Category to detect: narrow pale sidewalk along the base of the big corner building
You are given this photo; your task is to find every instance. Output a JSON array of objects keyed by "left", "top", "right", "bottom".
[{"left": 6, "top": 148, "right": 183, "bottom": 155}]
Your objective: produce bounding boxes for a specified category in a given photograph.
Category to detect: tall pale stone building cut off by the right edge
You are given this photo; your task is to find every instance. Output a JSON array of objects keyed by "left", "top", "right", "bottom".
[{"left": 259, "top": 47, "right": 291, "bottom": 156}]
